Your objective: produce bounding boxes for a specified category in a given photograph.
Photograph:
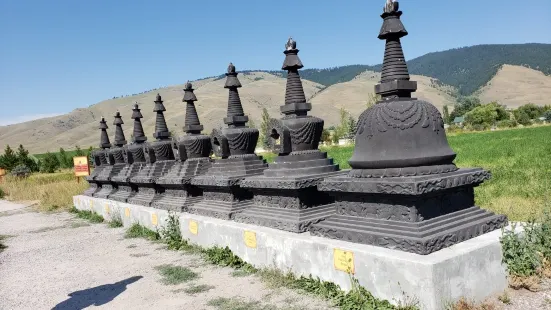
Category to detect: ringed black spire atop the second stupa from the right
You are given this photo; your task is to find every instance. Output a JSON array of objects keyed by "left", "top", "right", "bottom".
[{"left": 281, "top": 37, "right": 312, "bottom": 115}]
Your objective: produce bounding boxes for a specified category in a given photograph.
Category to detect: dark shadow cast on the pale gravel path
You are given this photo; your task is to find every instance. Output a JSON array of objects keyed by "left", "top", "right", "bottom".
[{"left": 52, "top": 276, "right": 143, "bottom": 310}]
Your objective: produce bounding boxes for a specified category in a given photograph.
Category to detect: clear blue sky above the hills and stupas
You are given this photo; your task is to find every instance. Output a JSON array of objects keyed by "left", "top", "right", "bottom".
[{"left": 0, "top": 0, "right": 551, "bottom": 125}]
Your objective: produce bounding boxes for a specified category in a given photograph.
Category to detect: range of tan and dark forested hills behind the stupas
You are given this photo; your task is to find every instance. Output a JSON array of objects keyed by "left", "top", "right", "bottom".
[{"left": 0, "top": 44, "right": 551, "bottom": 153}]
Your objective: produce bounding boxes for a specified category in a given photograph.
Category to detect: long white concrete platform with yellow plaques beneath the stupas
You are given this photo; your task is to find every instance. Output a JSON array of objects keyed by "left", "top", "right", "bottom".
[{"left": 73, "top": 196, "right": 507, "bottom": 310}]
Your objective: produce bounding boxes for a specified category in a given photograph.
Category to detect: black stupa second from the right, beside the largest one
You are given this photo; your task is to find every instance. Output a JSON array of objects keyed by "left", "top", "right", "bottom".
[{"left": 235, "top": 38, "right": 339, "bottom": 232}]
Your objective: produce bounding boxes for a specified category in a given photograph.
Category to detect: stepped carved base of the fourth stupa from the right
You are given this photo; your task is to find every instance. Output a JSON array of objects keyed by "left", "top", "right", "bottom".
[{"left": 151, "top": 184, "right": 203, "bottom": 212}]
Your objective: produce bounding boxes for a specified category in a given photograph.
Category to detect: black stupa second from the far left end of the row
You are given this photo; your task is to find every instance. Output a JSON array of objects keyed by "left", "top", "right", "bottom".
[{"left": 94, "top": 111, "right": 127, "bottom": 199}]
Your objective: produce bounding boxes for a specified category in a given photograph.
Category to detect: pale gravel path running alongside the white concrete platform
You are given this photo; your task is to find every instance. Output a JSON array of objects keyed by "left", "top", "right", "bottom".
[{"left": 0, "top": 200, "right": 331, "bottom": 310}]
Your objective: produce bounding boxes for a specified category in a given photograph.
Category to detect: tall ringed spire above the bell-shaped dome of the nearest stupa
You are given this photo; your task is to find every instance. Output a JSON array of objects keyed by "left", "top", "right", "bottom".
[{"left": 375, "top": 0, "right": 417, "bottom": 100}]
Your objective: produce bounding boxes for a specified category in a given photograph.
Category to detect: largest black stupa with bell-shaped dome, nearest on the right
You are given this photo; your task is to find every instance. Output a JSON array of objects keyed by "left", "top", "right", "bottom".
[{"left": 311, "top": 1, "right": 507, "bottom": 254}]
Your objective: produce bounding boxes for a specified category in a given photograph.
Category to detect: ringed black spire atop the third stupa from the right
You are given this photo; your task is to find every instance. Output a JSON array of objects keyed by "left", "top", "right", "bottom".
[{"left": 224, "top": 62, "right": 249, "bottom": 127}]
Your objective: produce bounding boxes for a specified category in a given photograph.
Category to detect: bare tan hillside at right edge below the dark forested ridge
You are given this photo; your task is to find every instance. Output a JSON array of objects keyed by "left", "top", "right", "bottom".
[{"left": 477, "top": 65, "right": 551, "bottom": 108}]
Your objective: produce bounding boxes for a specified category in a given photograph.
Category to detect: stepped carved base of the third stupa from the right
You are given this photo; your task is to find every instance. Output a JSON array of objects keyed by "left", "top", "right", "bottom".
[{"left": 187, "top": 186, "right": 252, "bottom": 220}]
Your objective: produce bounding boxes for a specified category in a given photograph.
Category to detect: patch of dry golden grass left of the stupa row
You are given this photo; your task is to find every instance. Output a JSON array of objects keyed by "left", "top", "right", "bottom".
[{"left": 0, "top": 171, "right": 88, "bottom": 211}]
